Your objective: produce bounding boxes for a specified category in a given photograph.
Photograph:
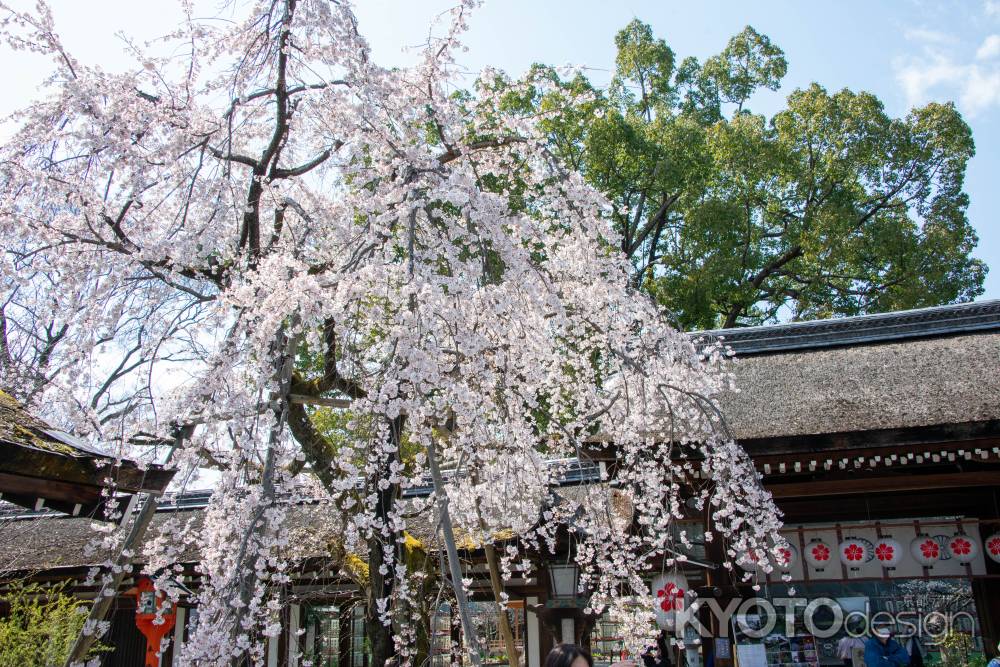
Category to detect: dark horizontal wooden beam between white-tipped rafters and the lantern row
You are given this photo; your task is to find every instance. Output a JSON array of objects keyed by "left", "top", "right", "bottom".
[{"left": 765, "top": 470, "right": 1000, "bottom": 498}]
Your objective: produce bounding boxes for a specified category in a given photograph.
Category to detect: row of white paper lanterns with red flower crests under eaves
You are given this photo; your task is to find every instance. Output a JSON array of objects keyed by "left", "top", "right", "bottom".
[{"left": 756, "top": 533, "right": 1000, "bottom": 572}]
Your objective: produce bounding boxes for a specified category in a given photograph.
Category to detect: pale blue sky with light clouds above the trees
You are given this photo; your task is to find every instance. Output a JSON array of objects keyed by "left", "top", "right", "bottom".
[{"left": 0, "top": 0, "right": 1000, "bottom": 298}]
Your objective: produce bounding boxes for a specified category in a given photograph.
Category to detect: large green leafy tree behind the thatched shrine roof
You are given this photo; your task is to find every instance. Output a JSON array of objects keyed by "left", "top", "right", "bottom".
[{"left": 520, "top": 20, "right": 986, "bottom": 328}]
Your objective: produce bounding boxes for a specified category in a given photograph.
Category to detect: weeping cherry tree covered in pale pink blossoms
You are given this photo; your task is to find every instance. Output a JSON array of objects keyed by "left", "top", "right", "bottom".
[{"left": 0, "top": 0, "right": 783, "bottom": 666}]
